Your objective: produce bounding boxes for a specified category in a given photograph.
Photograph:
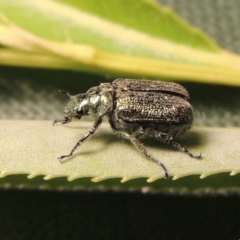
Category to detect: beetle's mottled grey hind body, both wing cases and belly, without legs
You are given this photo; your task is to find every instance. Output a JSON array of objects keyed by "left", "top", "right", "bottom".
[{"left": 110, "top": 79, "right": 193, "bottom": 137}]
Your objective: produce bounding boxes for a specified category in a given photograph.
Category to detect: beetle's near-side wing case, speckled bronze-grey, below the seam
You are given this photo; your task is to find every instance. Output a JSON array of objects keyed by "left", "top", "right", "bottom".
[{"left": 116, "top": 92, "right": 193, "bottom": 123}]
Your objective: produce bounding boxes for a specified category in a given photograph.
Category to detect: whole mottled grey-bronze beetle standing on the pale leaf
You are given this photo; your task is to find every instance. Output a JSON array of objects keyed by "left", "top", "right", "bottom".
[{"left": 53, "top": 78, "right": 201, "bottom": 177}]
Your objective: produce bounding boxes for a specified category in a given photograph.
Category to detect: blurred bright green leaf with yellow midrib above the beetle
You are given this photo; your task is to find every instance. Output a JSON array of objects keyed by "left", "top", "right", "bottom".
[{"left": 0, "top": 0, "right": 240, "bottom": 85}]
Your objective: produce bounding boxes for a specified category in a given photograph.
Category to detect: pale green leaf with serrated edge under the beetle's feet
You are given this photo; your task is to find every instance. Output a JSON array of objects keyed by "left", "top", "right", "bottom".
[{"left": 0, "top": 120, "right": 240, "bottom": 190}]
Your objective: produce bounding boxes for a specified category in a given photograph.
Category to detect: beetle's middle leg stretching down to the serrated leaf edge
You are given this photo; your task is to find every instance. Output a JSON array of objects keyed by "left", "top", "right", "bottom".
[{"left": 115, "top": 130, "right": 168, "bottom": 178}]
